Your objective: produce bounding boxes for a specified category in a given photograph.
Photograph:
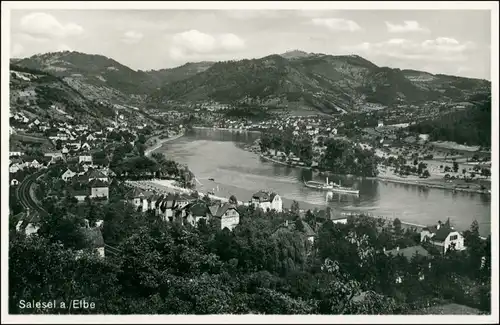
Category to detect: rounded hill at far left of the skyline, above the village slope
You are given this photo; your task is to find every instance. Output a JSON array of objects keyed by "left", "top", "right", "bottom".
[{"left": 15, "top": 51, "right": 156, "bottom": 103}]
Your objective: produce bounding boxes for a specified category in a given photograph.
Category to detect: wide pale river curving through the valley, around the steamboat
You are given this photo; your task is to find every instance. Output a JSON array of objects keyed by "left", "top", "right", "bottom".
[{"left": 158, "top": 129, "right": 491, "bottom": 236}]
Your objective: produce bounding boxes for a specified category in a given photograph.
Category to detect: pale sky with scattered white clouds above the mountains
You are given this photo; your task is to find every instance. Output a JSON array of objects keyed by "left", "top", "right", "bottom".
[{"left": 10, "top": 9, "right": 491, "bottom": 80}]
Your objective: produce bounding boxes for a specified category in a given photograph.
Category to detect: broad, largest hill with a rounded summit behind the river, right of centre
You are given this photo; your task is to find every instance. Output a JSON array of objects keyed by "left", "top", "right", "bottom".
[{"left": 148, "top": 51, "right": 491, "bottom": 113}]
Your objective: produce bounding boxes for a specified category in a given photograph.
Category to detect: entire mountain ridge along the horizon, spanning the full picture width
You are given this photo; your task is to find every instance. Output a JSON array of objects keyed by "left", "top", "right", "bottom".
[{"left": 11, "top": 50, "right": 491, "bottom": 113}]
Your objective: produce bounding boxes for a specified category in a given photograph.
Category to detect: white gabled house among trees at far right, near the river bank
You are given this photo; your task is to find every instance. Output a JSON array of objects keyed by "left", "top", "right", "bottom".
[{"left": 420, "top": 221, "right": 465, "bottom": 254}]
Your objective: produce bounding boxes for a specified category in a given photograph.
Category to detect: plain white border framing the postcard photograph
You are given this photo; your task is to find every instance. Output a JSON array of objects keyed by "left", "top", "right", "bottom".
[{"left": 1, "top": 1, "right": 499, "bottom": 324}]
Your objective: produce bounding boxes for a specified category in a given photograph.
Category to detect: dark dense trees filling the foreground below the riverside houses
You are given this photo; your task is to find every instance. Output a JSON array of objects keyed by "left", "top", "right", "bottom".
[{"left": 9, "top": 184, "right": 491, "bottom": 314}]
